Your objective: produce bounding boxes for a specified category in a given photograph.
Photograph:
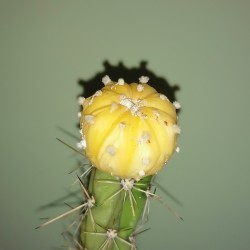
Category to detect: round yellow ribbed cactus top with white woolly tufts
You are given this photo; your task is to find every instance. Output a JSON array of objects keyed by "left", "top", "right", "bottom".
[{"left": 79, "top": 76, "right": 180, "bottom": 180}]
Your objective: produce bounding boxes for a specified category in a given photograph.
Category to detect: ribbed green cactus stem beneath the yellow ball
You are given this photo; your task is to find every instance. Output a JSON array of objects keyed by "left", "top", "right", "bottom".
[{"left": 81, "top": 169, "right": 151, "bottom": 250}]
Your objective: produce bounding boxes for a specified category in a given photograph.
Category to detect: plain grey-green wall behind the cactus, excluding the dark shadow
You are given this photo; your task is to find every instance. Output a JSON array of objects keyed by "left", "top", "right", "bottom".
[{"left": 0, "top": 0, "right": 250, "bottom": 250}]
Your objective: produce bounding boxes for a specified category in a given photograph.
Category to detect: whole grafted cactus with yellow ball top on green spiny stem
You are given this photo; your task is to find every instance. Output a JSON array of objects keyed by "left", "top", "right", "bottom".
[{"left": 37, "top": 76, "right": 180, "bottom": 250}]
